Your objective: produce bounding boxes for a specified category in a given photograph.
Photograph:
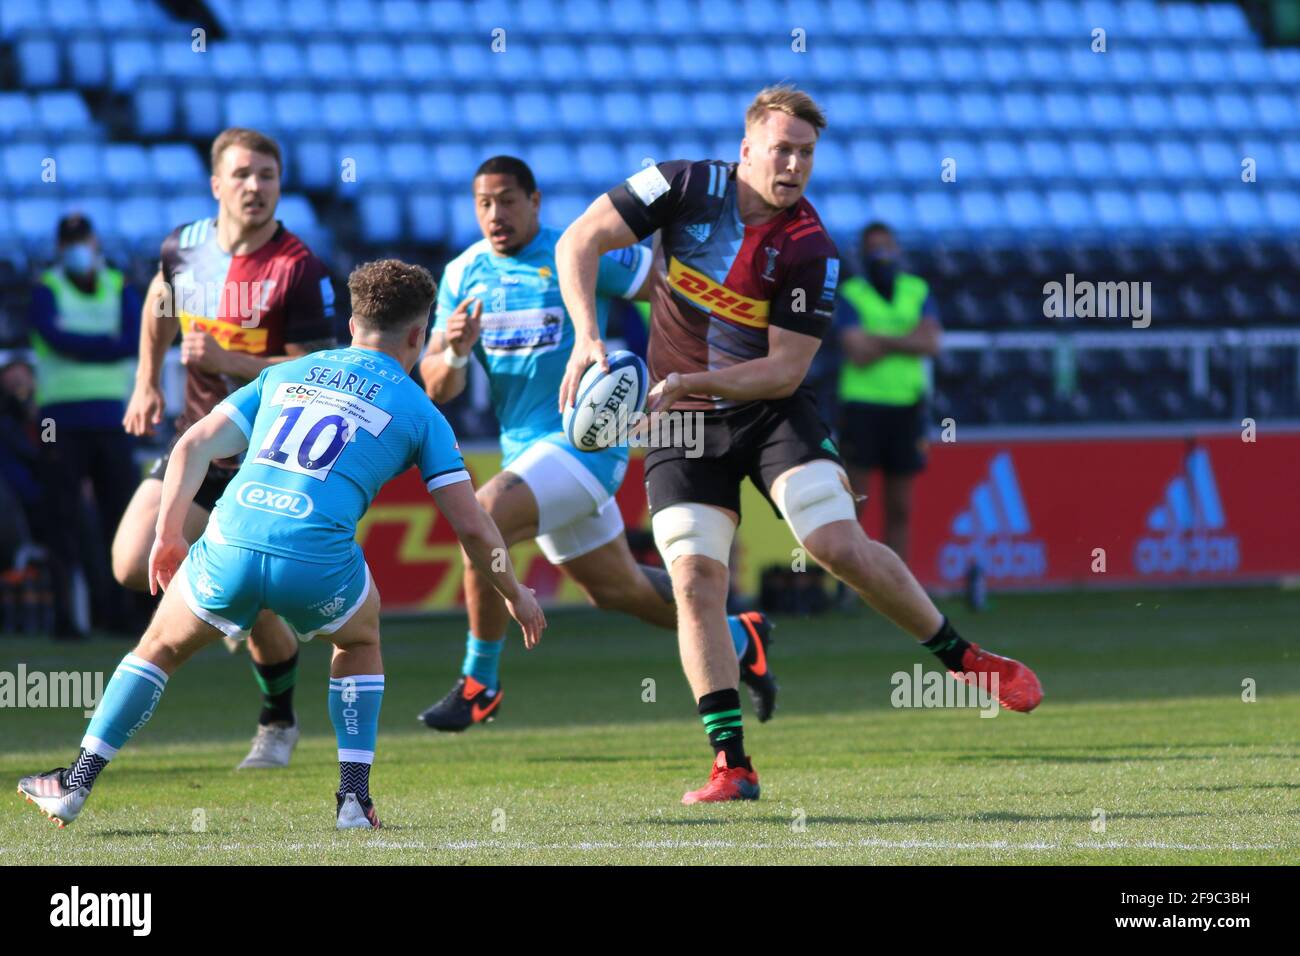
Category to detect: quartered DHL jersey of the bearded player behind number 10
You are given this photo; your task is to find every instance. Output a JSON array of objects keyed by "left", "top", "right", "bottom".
[{"left": 161, "top": 219, "right": 334, "bottom": 450}]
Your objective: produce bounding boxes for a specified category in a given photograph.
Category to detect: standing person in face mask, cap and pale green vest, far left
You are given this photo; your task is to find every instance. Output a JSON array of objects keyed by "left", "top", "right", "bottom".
[{"left": 27, "top": 213, "right": 142, "bottom": 630}]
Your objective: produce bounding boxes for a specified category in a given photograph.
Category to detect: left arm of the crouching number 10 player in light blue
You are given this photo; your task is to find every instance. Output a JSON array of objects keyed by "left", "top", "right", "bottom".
[{"left": 150, "top": 411, "right": 248, "bottom": 594}]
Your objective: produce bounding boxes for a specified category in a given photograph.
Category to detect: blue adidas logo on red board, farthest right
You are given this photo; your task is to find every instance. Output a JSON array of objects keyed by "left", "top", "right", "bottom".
[{"left": 1134, "top": 449, "right": 1242, "bottom": 575}]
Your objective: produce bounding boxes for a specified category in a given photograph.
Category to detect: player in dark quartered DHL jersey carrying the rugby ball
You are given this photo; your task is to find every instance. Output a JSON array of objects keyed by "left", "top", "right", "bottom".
[{"left": 555, "top": 86, "right": 1043, "bottom": 804}]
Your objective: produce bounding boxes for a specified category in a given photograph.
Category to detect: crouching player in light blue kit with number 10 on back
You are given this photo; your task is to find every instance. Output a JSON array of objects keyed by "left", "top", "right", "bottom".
[{"left": 18, "top": 259, "right": 546, "bottom": 830}]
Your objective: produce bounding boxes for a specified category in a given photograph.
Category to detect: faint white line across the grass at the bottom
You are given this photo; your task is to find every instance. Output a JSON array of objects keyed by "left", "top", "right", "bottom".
[{"left": 0, "top": 834, "right": 1279, "bottom": 855}]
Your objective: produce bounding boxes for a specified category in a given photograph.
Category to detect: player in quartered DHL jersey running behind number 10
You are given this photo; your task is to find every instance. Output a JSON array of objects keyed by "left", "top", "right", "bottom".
[{"left": 113, "top": 127, "right": 335, "bottom": 769}]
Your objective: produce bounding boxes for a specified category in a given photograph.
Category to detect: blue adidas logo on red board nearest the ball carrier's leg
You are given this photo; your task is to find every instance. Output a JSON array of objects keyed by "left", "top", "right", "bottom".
[{"left": 939, "top": 451, "right": 1048, "bottom": 581}]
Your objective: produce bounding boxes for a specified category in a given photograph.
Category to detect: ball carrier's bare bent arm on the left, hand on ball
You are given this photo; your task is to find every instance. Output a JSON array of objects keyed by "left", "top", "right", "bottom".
[{"left": 555, "top": 195, "right": 637, "bottom": 411}]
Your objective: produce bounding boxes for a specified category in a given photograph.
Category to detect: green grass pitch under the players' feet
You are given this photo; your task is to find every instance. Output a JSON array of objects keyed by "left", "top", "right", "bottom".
[{"left": 0, "top": 589, "right": 1300, "bottom": 865}]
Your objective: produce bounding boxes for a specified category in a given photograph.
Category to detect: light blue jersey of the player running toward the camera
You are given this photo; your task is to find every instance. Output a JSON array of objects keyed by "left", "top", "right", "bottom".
[{"left": 433, "top": 226, "right": 651, "bottom": 494}]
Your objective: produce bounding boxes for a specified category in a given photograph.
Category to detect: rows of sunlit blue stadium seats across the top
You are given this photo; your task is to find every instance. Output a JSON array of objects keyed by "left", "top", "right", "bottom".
[{"left": 0, "top": 0, "right": 1300, "bottom": 264}]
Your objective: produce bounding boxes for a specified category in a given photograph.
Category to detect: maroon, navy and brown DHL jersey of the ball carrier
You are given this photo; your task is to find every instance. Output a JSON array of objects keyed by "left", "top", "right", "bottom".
[{"left": 608, "top": 160, "right": 840, "bottom": 408}]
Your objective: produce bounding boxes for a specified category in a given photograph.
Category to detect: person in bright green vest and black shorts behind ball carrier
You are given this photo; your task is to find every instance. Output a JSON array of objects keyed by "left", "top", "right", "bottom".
[{"left": 836, "top": 222, "right": 943, "bottom": 561}]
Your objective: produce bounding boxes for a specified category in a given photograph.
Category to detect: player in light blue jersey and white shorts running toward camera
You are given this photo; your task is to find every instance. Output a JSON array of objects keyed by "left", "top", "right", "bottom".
[{"left": 420, "top": 156, "right": 776, "bottom": 731}]
